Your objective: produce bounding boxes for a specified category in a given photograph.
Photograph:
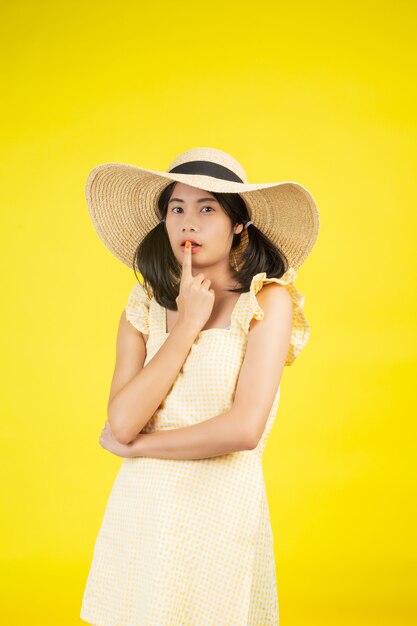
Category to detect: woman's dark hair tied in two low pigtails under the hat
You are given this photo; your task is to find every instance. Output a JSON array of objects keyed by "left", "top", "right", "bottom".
[{"left": 133, "top": 181, "right": 288, "bottom": 311}]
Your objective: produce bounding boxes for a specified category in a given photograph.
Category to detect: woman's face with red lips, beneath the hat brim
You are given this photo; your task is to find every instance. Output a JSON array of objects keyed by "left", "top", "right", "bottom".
[{"left": 166, "top": 183, "right": 243, "bottom": 269}]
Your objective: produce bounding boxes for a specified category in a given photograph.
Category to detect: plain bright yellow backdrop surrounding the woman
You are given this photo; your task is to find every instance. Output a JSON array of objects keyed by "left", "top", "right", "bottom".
[{"left": 0, "top": 0, "right": 417, "bottom": 626}]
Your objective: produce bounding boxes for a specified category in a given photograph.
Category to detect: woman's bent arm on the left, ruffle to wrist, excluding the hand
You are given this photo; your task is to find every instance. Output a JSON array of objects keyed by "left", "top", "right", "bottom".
[{"left": 107, "top": 312, "right": 199, "bottom": 444}]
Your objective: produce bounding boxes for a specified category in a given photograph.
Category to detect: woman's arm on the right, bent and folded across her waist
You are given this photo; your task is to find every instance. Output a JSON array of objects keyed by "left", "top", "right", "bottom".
[{"left": 100, "top": 283, "right": 292, "bottom": 459}]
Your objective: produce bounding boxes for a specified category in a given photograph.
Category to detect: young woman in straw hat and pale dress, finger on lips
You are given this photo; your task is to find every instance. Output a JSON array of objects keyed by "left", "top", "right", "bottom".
[{"left": 80, "top": 148, "right": 319, "bottom": 626}]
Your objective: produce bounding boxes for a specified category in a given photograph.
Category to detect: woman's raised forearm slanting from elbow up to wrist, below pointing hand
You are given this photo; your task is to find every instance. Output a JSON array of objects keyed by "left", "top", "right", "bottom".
[{"left": 107, "top": 322, "right": 198, "bottom": 444}]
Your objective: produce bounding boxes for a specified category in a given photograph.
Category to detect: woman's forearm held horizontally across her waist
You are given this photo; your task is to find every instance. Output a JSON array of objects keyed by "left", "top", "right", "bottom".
[{"left": 129, "top": 408, "right": 252, "bottom": 459}]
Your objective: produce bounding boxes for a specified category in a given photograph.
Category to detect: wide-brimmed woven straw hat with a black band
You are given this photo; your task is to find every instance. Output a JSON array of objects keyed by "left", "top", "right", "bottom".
[{"left": 85, "top": 148, "right": 320, "bottom": 269}]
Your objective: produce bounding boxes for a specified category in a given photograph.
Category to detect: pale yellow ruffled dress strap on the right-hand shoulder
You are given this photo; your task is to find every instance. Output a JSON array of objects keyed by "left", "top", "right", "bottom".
[{"left": 246, "top": 267, "right": 310, "bottom": 365}]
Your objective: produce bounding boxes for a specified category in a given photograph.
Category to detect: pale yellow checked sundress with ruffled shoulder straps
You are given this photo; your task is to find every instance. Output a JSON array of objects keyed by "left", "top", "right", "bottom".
[{"left": 80, "top": 267, "right": 310, "bottom": 626}]
